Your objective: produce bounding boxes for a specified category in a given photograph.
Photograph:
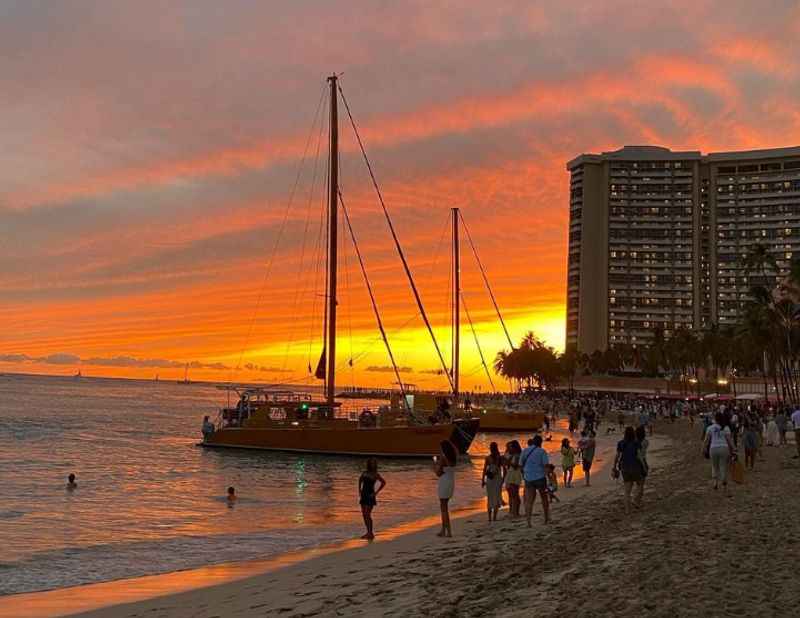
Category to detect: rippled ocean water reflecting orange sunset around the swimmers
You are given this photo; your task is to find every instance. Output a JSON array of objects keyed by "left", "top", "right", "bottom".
[{"left": 0, "top": 376, "right": 556, "bottom": 594}]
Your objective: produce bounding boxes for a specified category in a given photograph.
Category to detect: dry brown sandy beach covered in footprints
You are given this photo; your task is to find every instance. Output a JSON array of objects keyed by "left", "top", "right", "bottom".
[{"left": 7, "top": 421, "right": 800, "bottom": 618}]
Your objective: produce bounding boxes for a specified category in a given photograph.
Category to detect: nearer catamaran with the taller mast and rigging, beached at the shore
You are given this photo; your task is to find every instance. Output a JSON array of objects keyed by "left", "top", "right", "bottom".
[{"left": 200, "top": 75, "right": 479, "bottom": 457}]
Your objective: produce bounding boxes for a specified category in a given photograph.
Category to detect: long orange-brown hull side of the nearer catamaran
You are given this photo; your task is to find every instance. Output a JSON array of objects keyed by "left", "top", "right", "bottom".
[{"left": 199, "top": 425, "right": 472, "bottom": 457}]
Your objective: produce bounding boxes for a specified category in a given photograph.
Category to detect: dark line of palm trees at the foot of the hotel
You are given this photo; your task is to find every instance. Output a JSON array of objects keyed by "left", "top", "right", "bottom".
[{"left": 494, "top": 244, "right": 800, "bottom": 404}]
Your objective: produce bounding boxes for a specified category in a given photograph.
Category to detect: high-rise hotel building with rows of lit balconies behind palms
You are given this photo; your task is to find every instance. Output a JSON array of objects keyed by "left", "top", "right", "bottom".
[{"left": 566, "top": 146, "right": 800, "bottom": 353}]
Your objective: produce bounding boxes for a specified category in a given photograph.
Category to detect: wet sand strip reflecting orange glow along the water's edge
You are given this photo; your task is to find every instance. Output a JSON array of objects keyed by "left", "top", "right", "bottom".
[{"left": 0, "top": 434, "right": 632, "bottom": 618}]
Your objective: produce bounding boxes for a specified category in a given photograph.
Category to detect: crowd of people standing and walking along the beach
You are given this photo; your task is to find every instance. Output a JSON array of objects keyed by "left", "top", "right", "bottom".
[{"left": 359, "top": 392, "right": 800, "bottom": 539}]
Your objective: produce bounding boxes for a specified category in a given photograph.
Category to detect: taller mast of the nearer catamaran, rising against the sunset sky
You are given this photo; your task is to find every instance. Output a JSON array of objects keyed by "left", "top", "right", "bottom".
[{"left": 326, "top": 73, "right": 339, "bottom": 407}]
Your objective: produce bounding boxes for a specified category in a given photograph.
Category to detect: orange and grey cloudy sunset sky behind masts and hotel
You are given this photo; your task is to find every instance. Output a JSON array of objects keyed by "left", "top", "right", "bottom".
[{"left": 0, "top": 0, "right": 800, "bottom": 388}]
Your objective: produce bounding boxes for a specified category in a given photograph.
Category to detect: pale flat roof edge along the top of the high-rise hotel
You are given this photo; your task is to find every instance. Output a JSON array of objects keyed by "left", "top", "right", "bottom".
[{"left": 567, "top": 145, "right": 800, "bottom": 170}]
